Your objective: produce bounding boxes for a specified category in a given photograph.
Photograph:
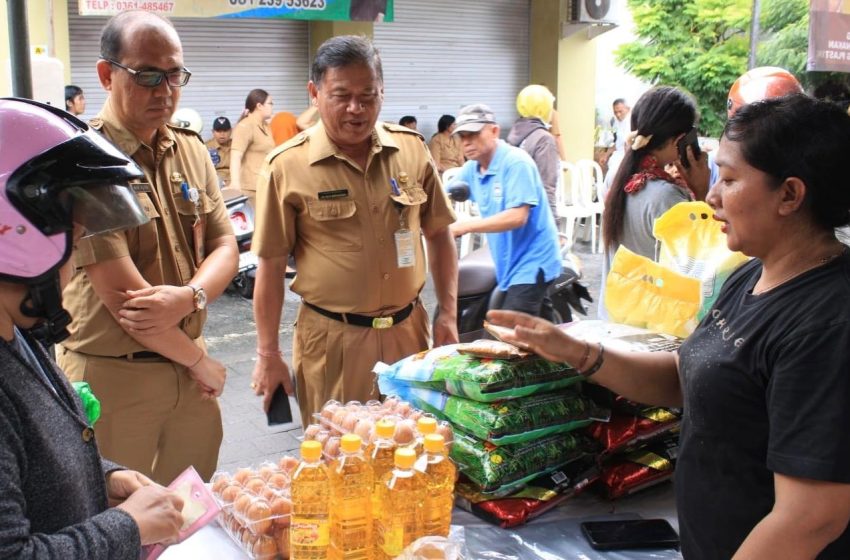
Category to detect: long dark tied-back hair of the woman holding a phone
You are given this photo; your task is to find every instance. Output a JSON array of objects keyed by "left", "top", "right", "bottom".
[{"left": 602, "top": 86, "right": 699, "bottom": 247}]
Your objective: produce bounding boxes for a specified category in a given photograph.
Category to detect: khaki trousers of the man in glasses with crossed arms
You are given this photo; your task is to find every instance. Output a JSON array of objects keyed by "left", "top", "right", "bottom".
[{"left": 56, "top": 346, "right": 222, "bottom": 485}]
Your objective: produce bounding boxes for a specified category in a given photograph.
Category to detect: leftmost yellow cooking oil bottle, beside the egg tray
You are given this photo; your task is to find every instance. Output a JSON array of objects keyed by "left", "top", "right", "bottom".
[{"left": 289, "top": 441, "right": 330, "bottom": 560}]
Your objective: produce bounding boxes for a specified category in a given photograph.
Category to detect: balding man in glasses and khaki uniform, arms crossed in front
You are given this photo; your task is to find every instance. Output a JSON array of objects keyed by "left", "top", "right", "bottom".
[{"left": 57, "top": 11, "right": 238, "bottom": 483}]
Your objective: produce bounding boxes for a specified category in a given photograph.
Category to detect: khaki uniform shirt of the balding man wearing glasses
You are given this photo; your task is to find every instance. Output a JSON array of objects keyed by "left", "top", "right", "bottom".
[{"left": 62, "top": 101, "right": 233, "bottom": 356}]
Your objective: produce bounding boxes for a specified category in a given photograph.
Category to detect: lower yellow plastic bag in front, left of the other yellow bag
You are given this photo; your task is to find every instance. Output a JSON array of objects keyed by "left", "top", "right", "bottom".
[{"left": 605, "top": 246, "right": 700, "bottom": 338}]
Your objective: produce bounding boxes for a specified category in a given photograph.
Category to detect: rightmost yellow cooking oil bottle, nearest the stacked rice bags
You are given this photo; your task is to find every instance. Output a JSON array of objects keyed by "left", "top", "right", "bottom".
[{"left": 416, "top": 434, "right": 457, "bottom": 537}]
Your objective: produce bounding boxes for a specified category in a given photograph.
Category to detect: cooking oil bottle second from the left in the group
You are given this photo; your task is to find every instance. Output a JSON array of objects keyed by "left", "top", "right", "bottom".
[{"left": 328, "top": 434, "right": 374, "bottom": 560}]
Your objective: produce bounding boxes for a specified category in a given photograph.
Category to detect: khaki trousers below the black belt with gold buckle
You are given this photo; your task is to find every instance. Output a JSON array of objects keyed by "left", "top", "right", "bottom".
[{"left": 292, "top": 301, "right": 430, "bottom": 426}]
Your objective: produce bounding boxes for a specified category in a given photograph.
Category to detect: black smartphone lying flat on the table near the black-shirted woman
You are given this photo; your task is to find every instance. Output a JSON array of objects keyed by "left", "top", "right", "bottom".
[{"left": 581, "top": 519, "right": 679, "bottom": 550}]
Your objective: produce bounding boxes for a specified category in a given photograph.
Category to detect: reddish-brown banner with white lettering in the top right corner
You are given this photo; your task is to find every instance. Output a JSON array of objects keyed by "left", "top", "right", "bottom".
[{"left": 806, "top": 0, "right": 850, "bottom": 72}]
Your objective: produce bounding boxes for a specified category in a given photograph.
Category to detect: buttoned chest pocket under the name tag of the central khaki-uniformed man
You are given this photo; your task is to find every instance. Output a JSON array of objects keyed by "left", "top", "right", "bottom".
[{"left": 301, "top": 200, "right": 363, "bottom": 253}]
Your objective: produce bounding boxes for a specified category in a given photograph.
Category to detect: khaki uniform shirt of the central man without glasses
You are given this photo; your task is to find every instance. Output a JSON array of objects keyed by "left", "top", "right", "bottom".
[{"left": 252, "top": 123, "right": 454, "bottom": 315}]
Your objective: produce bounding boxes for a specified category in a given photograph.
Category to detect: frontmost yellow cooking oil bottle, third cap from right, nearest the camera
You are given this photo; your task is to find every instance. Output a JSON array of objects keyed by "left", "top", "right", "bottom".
[{"left": 375, "top": 447, "right": 427, "bottom": 560}]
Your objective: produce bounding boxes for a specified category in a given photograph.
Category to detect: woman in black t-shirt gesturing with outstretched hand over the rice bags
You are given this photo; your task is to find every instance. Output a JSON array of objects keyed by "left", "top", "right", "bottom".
[{"left": 488, "top": 94, "right": 850, "bottom": 559}]
